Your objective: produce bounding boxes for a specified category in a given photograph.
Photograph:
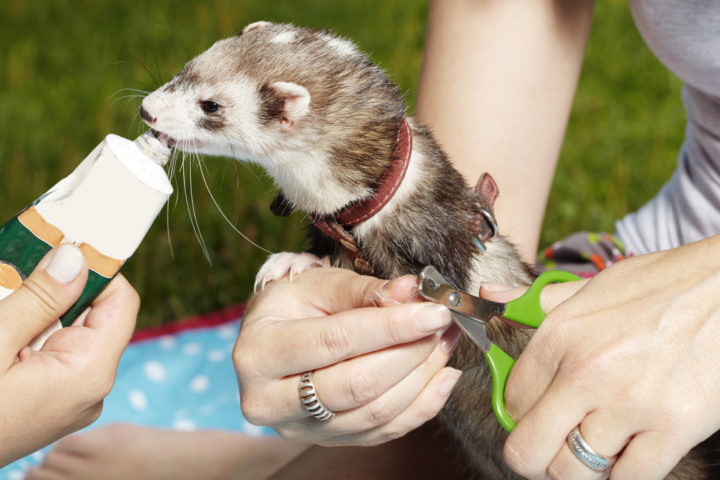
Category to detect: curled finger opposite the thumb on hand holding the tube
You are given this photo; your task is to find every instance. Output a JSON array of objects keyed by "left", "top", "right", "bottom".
[{"left": 83, "top": 274, "right": 140, "bottom": 361}]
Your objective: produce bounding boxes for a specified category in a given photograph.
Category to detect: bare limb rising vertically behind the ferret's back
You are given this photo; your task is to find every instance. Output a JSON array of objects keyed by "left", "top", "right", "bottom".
[{"left": 416, "top": 0, "right": 593, "bottom": 262}]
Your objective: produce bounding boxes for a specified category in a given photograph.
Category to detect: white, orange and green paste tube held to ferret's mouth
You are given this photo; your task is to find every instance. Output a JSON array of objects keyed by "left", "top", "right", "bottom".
[{"left": 0, "top": 131, "right": 173, "bottom": 348}]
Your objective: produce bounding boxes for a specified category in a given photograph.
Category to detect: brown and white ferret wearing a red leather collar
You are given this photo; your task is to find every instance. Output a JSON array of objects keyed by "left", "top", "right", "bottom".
[{"left": 140, "top": 22, "right": 711, "bottom": 479}]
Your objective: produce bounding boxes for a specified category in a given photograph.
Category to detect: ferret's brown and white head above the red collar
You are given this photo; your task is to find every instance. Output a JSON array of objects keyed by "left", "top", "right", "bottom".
[{"left": 140, "top": 22, "right": 405, "bottom": 213}]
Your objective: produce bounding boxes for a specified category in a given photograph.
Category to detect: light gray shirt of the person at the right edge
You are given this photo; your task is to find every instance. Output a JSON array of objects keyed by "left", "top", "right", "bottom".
[{"left": 615, "top": 0, "right": 720, "bottom": 254}]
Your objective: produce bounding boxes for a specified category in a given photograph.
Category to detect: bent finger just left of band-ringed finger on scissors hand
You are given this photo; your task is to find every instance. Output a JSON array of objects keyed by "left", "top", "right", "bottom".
[{"left": 503, "top": 381, "right": 590, "bottom": 478}]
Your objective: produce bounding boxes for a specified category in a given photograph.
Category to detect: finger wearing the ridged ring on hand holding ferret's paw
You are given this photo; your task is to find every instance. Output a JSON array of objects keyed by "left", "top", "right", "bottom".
[{"left": 241, "top": 328, "right": 460, "bottom": 424}]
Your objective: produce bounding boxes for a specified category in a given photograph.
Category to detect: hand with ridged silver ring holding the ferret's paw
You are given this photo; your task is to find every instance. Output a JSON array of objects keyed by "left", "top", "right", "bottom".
[{"left": 233, "top": 268, "right": 460, "bottom": 445}]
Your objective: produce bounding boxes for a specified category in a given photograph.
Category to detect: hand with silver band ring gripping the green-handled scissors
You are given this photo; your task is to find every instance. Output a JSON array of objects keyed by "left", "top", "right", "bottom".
[{"left": 481, "top": 238, "right": 720, "bottom": 480}]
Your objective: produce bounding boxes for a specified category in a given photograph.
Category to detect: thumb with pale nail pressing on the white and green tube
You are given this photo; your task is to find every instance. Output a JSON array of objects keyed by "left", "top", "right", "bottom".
[{"left": 0, "top": 244, "right": 87, "bottom": 365}]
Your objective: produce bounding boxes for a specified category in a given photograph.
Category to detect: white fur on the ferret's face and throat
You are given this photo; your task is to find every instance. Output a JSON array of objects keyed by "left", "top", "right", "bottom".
[{"left": 143, "top": 64, "right": 367, "bottom": 213}]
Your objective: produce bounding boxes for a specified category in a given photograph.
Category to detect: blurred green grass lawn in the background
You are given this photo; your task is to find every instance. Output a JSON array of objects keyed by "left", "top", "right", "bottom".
[{"left": 0, "top": 0, "right": 684, "bottom": 325}]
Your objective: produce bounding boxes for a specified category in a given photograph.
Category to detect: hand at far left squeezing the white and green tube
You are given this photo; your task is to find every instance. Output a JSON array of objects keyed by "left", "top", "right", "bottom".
[{"left": 0, "top": 245, "right": 139, "bottom": 465}]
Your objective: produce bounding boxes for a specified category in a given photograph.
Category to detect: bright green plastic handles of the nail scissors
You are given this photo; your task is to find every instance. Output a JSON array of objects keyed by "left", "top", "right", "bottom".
[{"left": 485, "top": 270, "right": 580, "bottom": 432}]
